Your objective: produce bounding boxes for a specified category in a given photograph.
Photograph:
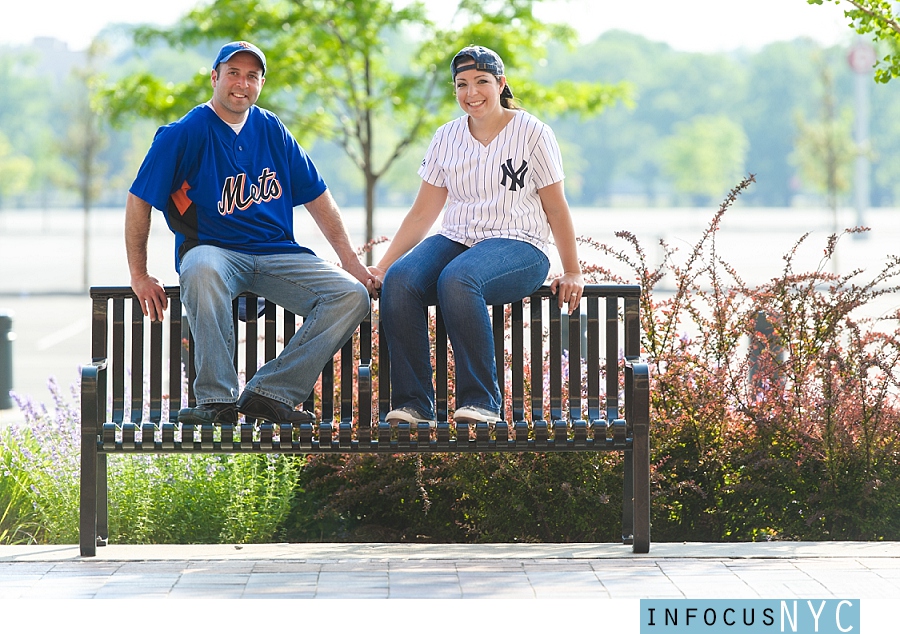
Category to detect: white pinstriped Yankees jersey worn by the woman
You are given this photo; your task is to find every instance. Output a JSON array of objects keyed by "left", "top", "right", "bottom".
[{"left": 419, "top": 110, "right": 564, "bottom": 253}]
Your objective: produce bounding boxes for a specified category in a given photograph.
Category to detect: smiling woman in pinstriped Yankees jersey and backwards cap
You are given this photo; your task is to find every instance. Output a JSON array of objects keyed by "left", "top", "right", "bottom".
[{"left": 369, "top": 46, "right": 584, "bottom": 425}]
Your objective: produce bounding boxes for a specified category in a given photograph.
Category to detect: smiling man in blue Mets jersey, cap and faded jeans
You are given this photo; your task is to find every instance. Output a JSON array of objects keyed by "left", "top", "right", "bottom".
[{"left": 125, "top": 42, "right": 371, "bottom": 424}]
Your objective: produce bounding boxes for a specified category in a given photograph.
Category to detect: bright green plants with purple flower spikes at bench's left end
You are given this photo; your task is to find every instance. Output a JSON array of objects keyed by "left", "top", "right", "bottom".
[{"left": 0, "top": 382, "right": 304, "bottom": 544}]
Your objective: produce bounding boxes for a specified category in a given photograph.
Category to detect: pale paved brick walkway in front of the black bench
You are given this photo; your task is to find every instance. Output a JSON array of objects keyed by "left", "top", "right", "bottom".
[{"left": 0, "top": 542, "right": 900, "bottom": 600}]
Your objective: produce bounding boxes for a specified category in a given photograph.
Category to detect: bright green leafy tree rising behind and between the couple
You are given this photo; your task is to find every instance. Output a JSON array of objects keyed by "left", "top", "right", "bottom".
[{"left": 104, "top": 0, "right": 628, "bottom": 258}]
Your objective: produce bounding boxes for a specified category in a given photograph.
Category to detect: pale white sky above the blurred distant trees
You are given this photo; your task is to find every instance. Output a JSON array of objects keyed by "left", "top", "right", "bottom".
[{"left": 0, "top": 0, "right": 853, "bottom": 52}]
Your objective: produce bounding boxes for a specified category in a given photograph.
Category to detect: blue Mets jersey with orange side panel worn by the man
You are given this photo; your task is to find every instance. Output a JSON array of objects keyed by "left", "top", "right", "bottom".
[{"left": 130, "top": 104, "right": 326, "bottom": 271}]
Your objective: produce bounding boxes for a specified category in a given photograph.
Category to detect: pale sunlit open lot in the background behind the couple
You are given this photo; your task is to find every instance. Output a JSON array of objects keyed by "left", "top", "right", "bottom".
[{"left": 0, "top": 205, "right": 900, "bottom": 410}]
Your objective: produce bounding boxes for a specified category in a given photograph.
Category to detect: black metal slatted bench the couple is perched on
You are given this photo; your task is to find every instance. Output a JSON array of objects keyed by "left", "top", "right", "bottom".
[{"left": 80, "top": 285, "right": 650, "bottom": 557}]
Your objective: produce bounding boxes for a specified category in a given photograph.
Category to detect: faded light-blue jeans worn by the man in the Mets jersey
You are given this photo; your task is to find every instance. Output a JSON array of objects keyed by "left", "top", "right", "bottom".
[{"left": 180, "top": 245, "right": 369, "bottom": 407}]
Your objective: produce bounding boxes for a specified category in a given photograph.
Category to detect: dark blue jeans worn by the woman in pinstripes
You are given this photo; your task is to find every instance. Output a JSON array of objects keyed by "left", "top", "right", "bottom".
[{"left": 380, "top": 235, "right": 550, "bottom": 418}]
